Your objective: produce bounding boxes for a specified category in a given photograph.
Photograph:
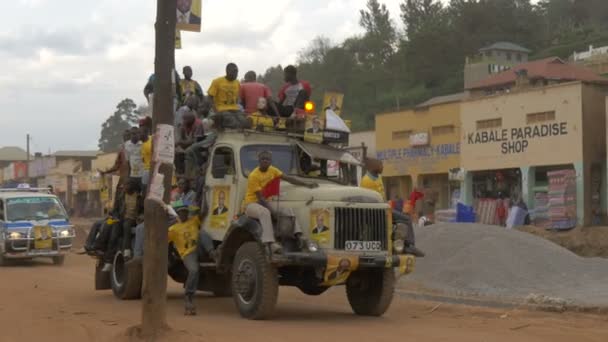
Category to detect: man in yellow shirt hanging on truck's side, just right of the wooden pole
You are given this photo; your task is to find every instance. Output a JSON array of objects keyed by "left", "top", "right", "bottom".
[{"left": 169, "top": 201, "right": 200, "bottom": 316}]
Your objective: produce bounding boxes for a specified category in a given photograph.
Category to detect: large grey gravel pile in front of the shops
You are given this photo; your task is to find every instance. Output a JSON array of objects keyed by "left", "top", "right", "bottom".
[{"left": 402, "top": 224, "right": 608, "bottom": 306}]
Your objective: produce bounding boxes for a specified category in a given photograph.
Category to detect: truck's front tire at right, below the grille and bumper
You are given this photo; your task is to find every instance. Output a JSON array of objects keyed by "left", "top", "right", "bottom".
[{"left": 346, "top": 268, "right": 395, "bottom": 316}]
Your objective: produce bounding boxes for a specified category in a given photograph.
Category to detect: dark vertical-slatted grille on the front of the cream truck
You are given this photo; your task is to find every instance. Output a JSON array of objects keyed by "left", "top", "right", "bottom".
[{"left": 334, "top": 208, "right": 388, "bottom": 250}]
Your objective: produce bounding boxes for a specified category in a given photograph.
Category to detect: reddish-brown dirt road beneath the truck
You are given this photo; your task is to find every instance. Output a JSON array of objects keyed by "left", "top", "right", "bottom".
[{"left": 0, "top": 255, "right": 608, "bottom": 342}]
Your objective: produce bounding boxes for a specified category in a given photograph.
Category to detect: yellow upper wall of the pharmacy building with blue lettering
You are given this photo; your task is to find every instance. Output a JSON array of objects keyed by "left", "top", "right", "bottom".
[{"left": 376, "top": 102, "right": 460, "bottom": 178}]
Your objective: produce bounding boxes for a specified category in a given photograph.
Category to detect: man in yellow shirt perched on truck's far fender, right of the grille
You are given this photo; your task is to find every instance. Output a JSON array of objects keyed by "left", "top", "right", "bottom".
[{"left": 361, "top": 158, "right": 424, "bottom": 257}]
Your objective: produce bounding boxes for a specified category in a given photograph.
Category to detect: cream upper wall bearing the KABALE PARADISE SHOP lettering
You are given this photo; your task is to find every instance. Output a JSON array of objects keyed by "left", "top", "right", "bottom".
[{"left": 461, "top": 82, "right": 583, "bottom": 171}]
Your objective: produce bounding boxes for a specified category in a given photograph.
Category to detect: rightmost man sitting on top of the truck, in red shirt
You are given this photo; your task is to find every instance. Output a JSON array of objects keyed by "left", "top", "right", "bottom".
[{"left": 277, "top": 65, "right": 312, "bottom": 117}]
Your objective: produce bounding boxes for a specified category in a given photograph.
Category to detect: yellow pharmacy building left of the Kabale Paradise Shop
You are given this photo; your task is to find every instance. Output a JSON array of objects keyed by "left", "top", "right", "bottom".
[{"left": 376, "top": 93, "right": 464, "bottom": 209}]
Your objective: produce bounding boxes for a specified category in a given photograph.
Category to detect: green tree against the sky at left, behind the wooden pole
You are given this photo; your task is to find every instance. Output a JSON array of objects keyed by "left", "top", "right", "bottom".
[{"left": 98, "top": 99, "right": 141, "bottom": 152}]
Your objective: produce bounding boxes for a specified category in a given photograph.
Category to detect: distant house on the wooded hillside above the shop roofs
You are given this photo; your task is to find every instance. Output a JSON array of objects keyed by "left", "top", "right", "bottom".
[{"left": 464, "top": 42, "right": 530, "bottom": 88}]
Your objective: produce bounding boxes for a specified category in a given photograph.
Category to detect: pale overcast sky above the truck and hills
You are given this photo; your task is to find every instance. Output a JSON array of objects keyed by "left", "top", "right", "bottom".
[{"left": 0, "top": 0, "right": 510, "bottom": 153}]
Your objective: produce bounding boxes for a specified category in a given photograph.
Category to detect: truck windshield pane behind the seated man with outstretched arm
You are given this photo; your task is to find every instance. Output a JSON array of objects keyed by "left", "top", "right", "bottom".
[{"left": 241, "top": 145, "right": 297, "bottom": 177}]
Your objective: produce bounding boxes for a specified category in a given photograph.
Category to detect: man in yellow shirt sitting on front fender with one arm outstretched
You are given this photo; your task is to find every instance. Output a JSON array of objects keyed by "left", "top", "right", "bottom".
[{"left": 245, "top": 151, "right": 318, "bottom": 254}]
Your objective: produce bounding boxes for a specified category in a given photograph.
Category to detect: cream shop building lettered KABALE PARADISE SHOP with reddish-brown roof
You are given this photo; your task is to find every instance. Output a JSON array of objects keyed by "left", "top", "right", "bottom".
[{"left": 460, "top": 58, "right": 608, "bottom": 225}]
